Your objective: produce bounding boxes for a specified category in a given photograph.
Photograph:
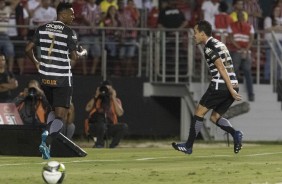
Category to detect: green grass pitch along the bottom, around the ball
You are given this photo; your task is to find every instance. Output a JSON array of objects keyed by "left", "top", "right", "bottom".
[{"left": 0, "top": 143, "right": 282, "bottom": 184}]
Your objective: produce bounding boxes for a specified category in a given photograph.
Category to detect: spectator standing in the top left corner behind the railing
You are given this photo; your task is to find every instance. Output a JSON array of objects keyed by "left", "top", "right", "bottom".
[{"left": 0, "top": 0, "right": 15, "bottom": 72}]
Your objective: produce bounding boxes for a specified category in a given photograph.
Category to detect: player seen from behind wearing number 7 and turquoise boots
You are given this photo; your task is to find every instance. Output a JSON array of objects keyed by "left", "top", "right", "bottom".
[{"left": 26, "top": 2, "right": 87, "bottom": 159}]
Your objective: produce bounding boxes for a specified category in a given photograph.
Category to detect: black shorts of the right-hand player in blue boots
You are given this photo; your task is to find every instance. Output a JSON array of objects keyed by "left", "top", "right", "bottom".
[{"left": 200, "top": 83, "right": 239, "bottom": 115}]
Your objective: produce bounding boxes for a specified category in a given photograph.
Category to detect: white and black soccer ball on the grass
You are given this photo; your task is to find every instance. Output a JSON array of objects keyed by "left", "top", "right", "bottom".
[{"left": 42, "top": 161, "right": 66, "bottom": 184}]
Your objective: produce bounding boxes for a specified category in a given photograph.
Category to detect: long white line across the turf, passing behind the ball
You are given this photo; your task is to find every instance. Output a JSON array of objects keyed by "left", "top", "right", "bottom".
[{"left": 0, "top": 152, "right": 282, "bottom": 167}]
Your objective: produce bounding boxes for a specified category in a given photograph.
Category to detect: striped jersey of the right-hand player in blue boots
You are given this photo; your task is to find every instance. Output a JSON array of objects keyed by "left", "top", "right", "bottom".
[{"left": 204, "top": 37, "right": 238, "bottom": 87}]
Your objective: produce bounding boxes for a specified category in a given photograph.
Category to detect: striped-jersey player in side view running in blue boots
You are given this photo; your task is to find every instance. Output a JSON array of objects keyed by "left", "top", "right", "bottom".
[{"left": 172, "top": 20, "right": 243, "bottom": 154}]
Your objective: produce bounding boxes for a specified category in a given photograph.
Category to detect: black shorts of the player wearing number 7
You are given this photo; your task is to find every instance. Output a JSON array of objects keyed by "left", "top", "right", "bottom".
[{"left": 42, "top": 85, "right": 73, "bottom": 108}]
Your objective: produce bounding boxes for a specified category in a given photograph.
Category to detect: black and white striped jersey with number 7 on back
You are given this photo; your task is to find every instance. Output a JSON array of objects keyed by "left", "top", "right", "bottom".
[{"left": 32, "top": 21, "right": 77, "bottom": 87}]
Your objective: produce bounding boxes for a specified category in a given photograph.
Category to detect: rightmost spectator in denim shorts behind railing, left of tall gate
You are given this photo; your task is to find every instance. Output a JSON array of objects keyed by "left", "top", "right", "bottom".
[{"left": 118, "top": 0, "right": 138, "bottom": 75}]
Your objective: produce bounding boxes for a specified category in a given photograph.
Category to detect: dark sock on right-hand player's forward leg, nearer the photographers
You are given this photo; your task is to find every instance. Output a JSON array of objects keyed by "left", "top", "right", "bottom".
[{"left": 186, "top": 115, "right": 204, "bottom": 148}]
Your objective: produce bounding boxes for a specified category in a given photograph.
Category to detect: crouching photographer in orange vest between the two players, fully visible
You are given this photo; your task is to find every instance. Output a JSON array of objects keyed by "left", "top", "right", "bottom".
[{"left": 85, "top": 81, "right": 128, "bottom": 148}]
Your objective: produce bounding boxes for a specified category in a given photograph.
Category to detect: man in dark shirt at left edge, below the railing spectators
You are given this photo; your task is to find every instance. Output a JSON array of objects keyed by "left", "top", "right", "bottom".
[{"left": 0, "top": 53, "right": 18, "bottom": 103}]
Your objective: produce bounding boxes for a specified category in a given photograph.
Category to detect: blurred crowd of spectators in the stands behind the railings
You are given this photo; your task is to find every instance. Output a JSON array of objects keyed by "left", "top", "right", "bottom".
[{"left": 0, "top": 0, "right": 282, "bottom": 80}]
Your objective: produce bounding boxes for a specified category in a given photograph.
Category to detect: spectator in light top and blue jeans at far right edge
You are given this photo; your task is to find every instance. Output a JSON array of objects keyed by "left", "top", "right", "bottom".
[{"left": 264, "top": 6, "right": 282, "bottom": 82}]
